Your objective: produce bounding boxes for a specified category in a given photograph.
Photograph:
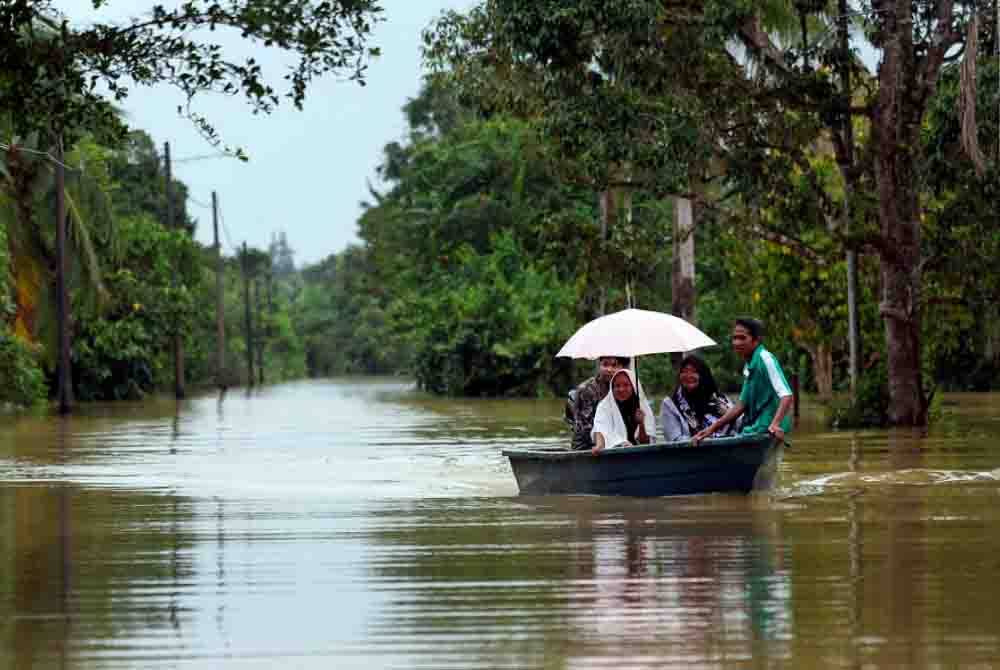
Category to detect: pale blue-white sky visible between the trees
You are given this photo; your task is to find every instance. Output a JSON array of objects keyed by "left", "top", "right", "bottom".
[{"left": 53, "top": 0, "right": 475, "bottom": 266}]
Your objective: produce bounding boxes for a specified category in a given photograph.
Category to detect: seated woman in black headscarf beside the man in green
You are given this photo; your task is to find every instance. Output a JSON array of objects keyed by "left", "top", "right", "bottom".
[{"left": 660, "top": 355, "right": 737, "bottom": 442}]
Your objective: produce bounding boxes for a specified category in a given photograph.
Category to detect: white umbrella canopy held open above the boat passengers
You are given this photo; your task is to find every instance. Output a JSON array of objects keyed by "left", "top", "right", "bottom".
[{"left": 556, "top": 309, "right": 715, "bottom": 358}]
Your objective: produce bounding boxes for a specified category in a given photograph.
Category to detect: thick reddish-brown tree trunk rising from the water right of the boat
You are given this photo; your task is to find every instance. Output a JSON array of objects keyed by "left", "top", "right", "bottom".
[{"left": 873, "top": 4, "right": 936, "bottom": 426}]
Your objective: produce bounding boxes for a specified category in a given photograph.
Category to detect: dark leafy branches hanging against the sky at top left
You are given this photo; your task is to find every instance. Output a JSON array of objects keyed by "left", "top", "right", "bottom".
[{"left": 0, "top": 0, "right": 381, "bottom": 148}]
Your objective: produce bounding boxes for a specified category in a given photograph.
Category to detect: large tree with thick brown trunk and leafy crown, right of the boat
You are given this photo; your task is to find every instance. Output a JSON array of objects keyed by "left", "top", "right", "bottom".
[{"left": 442, "top": 0, "right": 996, "bottom": 425}]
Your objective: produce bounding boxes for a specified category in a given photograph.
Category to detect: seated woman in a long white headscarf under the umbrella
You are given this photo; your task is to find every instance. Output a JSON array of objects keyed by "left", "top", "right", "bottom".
[{"left": 590, "top": 368, "right": 656, "bottom": 456}]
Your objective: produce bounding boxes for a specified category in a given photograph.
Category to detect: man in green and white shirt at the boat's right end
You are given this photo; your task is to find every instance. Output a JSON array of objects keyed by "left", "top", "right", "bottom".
[{"left": 691, "top": 319, "right": 794, "bottom": 444}]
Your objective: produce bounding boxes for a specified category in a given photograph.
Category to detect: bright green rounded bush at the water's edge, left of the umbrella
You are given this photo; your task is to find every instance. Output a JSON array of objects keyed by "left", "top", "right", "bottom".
[{"left": 393, "top": 233, "right": 573, "bottom": 396}]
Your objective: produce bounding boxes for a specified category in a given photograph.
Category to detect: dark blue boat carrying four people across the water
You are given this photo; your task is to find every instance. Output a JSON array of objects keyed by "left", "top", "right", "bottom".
[{"left": 503, "top": 433, "right": 782, "bottom": 496}]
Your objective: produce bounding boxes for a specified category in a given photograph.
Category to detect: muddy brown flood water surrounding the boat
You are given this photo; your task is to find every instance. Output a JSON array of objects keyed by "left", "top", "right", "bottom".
[{"left": 0, "top": 379, "right": 1000, "bottom": 669}]
